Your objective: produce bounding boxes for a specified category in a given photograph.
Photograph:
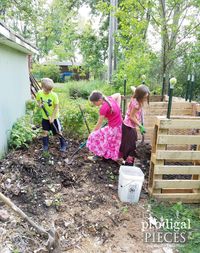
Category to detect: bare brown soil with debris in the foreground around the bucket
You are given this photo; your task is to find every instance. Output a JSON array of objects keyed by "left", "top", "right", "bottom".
[{"left": 0, "top": 139, "right": 175, "bottom": 253}]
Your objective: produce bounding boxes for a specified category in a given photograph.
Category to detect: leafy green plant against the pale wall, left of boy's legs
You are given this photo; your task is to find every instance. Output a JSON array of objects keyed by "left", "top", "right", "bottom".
[{"left": 8, "top": 115, "right": 39, "bottom": 149}]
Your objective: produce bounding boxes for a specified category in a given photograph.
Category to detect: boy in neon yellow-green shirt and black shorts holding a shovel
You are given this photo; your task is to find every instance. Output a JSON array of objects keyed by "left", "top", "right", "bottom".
[{"left": 36, "top": 78, "right": 67, "bottom": 152}]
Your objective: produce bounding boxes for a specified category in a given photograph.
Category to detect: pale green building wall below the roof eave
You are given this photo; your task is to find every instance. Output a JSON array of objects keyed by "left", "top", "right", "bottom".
[{"left": 0, "top": 44, "right": 30, "bottom": 155}]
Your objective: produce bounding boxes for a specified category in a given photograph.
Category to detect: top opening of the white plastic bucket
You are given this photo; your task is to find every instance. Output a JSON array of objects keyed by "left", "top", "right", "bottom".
[{"left": 119, "top": 165, "right": 144, "bottom": 180}]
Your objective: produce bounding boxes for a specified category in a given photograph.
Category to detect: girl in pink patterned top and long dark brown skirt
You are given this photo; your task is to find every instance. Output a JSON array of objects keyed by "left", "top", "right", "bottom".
[{"left": 120, "top": 85, "right": 150, "bottom": 166}]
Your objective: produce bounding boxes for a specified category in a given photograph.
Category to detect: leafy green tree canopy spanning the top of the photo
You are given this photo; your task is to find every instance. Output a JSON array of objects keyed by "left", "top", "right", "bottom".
[{"left": 0, "top": 0, "right": 200, "bottom": 95}]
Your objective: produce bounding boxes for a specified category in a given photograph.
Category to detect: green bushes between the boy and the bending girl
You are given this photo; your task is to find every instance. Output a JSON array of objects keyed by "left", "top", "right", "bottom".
[{"left": 54, "top": 80, "right": 118, "bottom": 139}]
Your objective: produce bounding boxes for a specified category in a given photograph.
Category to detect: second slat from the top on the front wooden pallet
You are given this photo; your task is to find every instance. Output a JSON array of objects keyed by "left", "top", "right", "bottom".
[{"left": 158, "top": 135, "right": 200, "bottom": 145}]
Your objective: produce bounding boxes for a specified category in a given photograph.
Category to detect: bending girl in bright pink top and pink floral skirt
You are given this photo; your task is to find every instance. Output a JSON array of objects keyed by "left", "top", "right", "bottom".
[{"left": 87, "top": 91, "right": 122, "bottom": 161}]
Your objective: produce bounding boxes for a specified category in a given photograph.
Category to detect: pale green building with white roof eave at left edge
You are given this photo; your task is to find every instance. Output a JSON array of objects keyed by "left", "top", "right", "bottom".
[{"left": 0, "top": 22, "right": 37, "bottom": 155}]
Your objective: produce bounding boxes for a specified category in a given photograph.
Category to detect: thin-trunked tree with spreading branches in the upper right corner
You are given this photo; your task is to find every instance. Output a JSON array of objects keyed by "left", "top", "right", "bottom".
[{"left": 152, "top": 0, "right": 200, "bottom": 93}]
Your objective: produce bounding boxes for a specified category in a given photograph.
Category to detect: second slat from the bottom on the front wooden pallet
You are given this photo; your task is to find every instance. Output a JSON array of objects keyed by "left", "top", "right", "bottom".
[{"left": 154, "top": 179, "right": 200, "bottom": 189}]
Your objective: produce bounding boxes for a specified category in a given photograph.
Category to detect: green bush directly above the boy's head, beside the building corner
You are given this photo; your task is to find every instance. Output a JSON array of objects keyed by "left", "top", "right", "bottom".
[{"left": 32, "top": 64, "right": 60, "bottom": 82}]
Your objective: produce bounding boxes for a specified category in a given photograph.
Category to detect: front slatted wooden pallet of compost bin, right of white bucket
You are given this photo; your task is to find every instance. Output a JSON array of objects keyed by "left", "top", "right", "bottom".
[{"left": 149, "top": 116, "right": 200, "bottom": 203}]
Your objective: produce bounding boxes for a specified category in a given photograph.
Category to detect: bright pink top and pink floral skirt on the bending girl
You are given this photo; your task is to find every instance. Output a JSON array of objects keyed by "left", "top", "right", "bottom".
[{"left": 86, "top": 97, "right": 122, "bottom": 160}]
